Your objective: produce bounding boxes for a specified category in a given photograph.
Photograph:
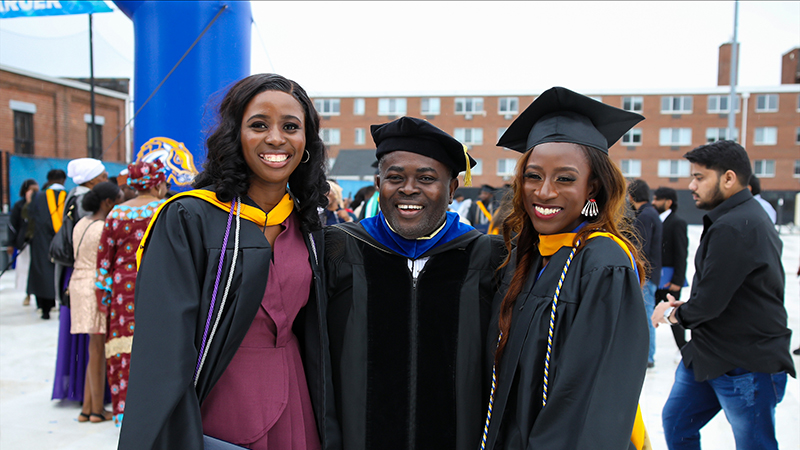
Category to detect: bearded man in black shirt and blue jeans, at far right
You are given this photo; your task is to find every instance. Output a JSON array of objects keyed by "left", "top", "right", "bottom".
[{"left": 651, "top": 141, "right": 796, "bottom": 450}]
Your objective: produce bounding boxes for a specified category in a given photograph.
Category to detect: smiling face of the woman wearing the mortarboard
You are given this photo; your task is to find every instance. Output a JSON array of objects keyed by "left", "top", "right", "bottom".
[{"left": 522, "top": 142, "right": 599, "bottom": 234}]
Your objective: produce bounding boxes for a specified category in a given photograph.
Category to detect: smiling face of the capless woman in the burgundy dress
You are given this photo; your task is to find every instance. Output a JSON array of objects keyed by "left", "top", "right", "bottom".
[{"left": 241, "top": 91, "right": 306, "bottom": 191}]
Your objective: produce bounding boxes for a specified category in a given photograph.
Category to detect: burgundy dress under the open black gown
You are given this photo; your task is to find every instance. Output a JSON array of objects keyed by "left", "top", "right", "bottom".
[{"left": 200, "top": 213, "right": 320, "bottom": 450}]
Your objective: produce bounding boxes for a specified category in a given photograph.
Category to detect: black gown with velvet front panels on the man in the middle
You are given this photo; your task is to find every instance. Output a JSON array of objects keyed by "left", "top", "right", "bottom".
[{"left": 323, "top": 223, "right": 505, "bottom": 450}]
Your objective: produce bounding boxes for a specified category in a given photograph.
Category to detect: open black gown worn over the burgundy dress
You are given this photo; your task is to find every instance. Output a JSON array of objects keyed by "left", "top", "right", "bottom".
[{"left": 119, "top": 193, "right": 327, "bottom": 450}]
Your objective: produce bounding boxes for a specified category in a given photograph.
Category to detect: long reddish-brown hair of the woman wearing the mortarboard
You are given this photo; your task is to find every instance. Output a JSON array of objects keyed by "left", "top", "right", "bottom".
[{"left": 495, "top": 144, "right": 646, "bottom": 362}]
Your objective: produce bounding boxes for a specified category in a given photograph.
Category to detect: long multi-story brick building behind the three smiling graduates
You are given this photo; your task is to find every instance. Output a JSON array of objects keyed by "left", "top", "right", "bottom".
[{"left": 314, "top": 44, "right": 800, "bottom": 222}]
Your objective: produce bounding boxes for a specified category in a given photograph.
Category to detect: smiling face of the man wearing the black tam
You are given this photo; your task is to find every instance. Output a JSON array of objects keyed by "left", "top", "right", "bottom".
[{"left": 378, "top": 151, "right": 458, "bottom": 239}]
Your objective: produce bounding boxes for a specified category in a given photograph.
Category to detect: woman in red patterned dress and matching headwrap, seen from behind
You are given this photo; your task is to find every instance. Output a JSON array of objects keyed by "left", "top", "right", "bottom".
[{"left": 97, "top": 160, "right": 168, "bottom": 425}]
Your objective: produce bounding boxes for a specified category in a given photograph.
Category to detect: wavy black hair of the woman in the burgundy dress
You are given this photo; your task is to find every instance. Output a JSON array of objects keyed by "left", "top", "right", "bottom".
[{"left": 192, "top": 73, "right": 328, "bottom": 232}]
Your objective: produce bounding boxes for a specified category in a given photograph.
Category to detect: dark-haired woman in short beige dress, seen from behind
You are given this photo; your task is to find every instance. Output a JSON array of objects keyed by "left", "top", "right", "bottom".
[{"left": 69, "top": 181, "right": 122, "bottom": 423}]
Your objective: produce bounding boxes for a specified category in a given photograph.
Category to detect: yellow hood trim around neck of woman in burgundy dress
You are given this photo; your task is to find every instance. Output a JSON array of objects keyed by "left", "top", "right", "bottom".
[{"left": 136, "top": 189, "right": 294, "bottom": 268}]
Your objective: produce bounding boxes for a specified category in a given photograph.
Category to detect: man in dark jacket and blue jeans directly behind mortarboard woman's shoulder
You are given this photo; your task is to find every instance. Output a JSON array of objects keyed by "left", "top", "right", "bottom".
[{"left": 628, "top": 180, "right": 662, "bottom": 368}]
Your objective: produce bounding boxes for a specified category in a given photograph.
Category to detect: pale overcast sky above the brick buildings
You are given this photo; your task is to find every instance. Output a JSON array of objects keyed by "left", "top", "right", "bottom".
[{"left": 0, "top": 1, "right": 800, "bottom": 95}]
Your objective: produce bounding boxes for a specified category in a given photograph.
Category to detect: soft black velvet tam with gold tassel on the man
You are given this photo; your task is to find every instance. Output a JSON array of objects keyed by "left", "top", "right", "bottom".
[{"left": 370, "top": 117, "right": 477, "bottom": 186}]
